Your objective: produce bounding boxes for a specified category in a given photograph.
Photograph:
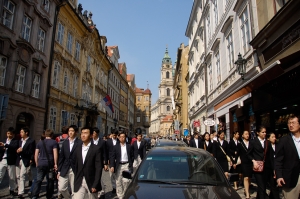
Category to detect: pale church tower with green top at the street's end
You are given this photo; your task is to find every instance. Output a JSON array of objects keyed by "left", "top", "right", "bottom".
[{"left": 150, "top": 49, "right": 175, "bottom": 136}]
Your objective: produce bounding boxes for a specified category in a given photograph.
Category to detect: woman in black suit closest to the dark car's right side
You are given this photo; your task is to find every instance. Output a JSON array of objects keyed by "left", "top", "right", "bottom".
[{"left": 213, "top": 131, "right": 231, "bottom": 178}]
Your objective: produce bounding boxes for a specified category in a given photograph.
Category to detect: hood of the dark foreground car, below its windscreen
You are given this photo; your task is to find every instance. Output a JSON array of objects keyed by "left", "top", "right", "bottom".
[{"left": 124, "top": 182, "right": 241, "bottom": 199}]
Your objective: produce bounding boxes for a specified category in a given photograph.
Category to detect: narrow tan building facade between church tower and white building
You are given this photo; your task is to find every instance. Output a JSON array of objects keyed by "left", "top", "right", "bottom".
[{"left": 173, "top": 43, "right": 189, "bottom": 136}]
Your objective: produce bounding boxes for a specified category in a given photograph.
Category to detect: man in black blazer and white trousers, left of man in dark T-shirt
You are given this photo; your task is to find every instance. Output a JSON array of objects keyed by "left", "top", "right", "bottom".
[{"left": 16, "top": 127, "right": 35, "bottom": 198}]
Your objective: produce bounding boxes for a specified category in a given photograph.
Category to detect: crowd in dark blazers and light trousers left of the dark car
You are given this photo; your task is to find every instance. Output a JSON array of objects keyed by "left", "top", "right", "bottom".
[{"left": 0, "top": 125, "right": 146, "bottom": 199}]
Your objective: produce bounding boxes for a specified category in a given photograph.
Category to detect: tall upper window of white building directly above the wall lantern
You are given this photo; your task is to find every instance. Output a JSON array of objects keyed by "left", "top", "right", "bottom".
[{"left": 240, "top": 7, "right": 250, "bottom": 54}]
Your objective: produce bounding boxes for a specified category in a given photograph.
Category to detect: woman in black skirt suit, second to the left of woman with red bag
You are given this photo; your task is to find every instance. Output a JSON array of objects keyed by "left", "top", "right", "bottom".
[{"left": 229, "top": 131, "right": 241, "bottom": 190}]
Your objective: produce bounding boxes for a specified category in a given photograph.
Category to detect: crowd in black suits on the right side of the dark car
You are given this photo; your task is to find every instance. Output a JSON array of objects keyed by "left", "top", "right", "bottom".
[{"left": 178, "top": 115, "right": 300, "bottom": 199}]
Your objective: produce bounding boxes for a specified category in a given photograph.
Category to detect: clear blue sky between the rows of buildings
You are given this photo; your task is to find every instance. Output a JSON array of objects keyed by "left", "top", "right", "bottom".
[{"left": 78, "top": 0, "right": 193, "bottom": 104}]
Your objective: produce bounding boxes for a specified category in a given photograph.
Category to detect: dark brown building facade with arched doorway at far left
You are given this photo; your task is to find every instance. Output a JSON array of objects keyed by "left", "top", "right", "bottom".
[{"left": 0, "top": 0, "right": 59, "bottom": 139}]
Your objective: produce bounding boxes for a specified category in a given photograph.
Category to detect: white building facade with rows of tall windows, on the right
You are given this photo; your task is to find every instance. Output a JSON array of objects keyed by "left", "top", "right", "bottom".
[{"left": 186, "top": 0, "right": 258, "bottom": 138}]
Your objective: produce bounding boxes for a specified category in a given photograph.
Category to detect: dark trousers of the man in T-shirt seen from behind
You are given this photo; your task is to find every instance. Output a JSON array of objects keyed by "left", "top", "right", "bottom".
[{"left": 32, "top": 166, "right": 54, "bottom": 198}]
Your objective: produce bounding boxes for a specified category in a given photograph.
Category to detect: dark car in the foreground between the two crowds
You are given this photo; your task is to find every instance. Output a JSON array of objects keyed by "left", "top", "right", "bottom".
[{"left": 123, "top": 147, "right": 241, "bottom": 199}]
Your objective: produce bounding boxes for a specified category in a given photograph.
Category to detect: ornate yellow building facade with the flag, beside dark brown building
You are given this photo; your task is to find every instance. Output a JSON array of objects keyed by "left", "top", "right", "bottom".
[{"left": 47, "top": 1, "right": 111, "bottom": 134}]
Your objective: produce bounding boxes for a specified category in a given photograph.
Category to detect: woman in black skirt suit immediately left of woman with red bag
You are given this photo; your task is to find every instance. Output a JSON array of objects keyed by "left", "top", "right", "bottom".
[{"left": 239, "top": 131, "right": 253, "bottom": 199}]
